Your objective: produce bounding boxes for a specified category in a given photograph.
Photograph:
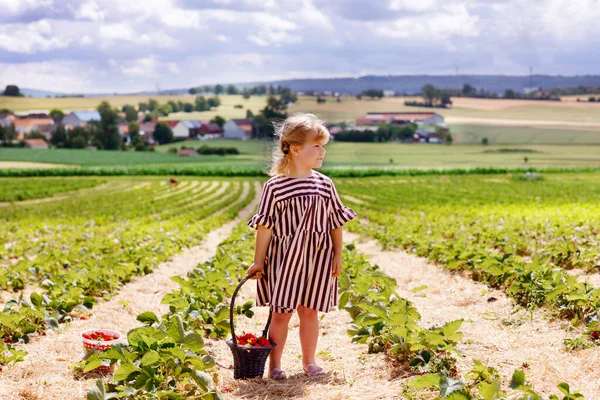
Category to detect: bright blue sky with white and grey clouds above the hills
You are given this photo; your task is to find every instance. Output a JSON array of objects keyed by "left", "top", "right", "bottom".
[{"left": 0, "top": 0, "right": 600, "bottom": 93}]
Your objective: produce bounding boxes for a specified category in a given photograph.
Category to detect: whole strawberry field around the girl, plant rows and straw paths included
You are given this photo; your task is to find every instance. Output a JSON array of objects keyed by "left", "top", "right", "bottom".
[{"left": 0, "top": 173, "right": 600, "bottom": 399}]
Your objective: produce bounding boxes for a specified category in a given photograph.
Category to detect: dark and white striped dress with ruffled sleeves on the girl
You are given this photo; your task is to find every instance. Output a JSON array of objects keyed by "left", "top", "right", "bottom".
[{"left": 247, "top": 171, "right": 356, "bottom": 313}]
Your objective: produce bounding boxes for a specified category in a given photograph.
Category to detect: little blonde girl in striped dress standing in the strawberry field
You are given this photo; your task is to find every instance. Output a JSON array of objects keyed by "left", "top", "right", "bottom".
[{"left": 247, "top": 113, "right": 356, "bottom": 379}]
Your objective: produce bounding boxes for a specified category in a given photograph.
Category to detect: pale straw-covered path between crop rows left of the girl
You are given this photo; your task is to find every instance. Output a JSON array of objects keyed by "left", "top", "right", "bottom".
[{"left": 0, "top": 182, "right": 261, "bottom": 400}]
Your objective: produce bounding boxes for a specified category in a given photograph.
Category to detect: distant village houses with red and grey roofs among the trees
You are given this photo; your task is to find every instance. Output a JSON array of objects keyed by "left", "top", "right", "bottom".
[{"left": 0, "top": 106, "right": 448, "bottom": 156}]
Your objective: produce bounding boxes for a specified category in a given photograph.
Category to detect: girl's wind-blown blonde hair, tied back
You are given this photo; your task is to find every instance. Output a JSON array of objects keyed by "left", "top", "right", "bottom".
[{"left": 268, "top": 113, "right": 329, "bottom": 176}]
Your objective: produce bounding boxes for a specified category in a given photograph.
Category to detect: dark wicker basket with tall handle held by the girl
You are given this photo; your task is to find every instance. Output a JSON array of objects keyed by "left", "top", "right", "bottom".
[{"left": 226, "top": 273, "right": 277, "bottom": 379}]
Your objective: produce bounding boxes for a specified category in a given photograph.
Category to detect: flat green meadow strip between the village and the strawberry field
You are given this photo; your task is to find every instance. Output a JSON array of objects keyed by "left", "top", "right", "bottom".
[{"left": 0, "top": 140, "right": 600, "bottom": 168}]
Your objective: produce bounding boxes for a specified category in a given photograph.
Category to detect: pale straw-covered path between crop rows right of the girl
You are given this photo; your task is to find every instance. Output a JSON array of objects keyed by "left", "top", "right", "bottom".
[{"left": 344, "top": 232, "right": 600, "bottom": 399}]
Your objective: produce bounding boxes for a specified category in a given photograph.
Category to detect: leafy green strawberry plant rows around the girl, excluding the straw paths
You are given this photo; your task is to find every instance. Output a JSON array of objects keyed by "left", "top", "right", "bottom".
[{"left": 0, "top": 173, "right": 600, "bottom": 399}]
